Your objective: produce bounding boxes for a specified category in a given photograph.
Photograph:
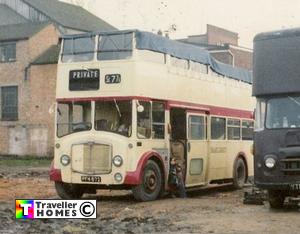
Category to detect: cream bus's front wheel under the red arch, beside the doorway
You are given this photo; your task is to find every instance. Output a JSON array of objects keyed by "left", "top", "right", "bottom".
[{"left": 132, "top": 160, "right": 162, "bottom": 201}]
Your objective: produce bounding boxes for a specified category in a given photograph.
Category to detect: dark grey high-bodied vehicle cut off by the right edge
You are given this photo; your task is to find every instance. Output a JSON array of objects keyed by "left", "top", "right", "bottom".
[{"left": 253, "top": 28, "right": 300, "bottom": 208}]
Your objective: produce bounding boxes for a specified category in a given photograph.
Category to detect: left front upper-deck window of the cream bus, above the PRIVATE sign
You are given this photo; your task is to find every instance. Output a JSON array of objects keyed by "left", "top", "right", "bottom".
[{"left": 62, "top": 36, "right": 95, "bottom": 63}]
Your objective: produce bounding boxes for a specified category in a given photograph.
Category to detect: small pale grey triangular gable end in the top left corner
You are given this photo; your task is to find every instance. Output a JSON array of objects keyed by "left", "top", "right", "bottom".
[{"left": 0, "top": 4, "right": 28, "bottom": 25}]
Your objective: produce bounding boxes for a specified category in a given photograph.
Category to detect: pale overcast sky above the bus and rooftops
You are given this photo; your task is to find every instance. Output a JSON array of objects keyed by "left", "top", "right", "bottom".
[{"left": 63, "top": 0, "right": 300, "bottom": 48}]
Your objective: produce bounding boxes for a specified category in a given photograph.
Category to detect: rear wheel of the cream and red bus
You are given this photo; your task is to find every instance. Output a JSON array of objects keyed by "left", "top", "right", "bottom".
[{"left": 233, "top": 158, "right": 247, "bottom": 189}]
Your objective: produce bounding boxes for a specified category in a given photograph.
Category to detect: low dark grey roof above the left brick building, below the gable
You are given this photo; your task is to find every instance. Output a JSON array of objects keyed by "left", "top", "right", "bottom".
[{"left": 0, "top": 22, "right": 50, "bottom": 41}]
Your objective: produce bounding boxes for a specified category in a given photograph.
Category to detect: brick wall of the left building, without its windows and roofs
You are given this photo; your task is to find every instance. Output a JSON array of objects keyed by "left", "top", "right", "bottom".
[{"left": 0, "top": 24, "right": 59, "bottom": 156}]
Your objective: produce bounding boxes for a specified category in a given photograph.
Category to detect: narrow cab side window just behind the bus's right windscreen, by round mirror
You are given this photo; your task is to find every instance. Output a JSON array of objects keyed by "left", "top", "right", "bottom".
[{"left": 137, "top": 101, "right": 151, "bottom": 139}]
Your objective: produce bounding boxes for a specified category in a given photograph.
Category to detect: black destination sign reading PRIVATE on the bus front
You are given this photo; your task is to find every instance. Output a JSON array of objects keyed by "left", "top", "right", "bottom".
[{"left": 69, "top": 69, "right": 100, "bottom": 91}]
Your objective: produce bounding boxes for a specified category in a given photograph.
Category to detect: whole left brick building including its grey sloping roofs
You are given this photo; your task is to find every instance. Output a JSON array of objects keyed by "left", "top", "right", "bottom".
[{"left": 0, "top": 0, "right": 116, "bottom": 156}]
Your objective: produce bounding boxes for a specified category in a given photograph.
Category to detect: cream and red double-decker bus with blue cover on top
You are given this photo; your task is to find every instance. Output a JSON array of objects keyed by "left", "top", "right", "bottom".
[{"left": 50, "top": 30, "right": 255, "bottom": 201}]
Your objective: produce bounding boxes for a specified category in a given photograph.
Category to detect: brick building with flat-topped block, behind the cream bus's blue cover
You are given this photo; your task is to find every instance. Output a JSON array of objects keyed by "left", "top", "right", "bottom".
[{"left": 179, "top": 24, "right": 252, "bottom": 70}]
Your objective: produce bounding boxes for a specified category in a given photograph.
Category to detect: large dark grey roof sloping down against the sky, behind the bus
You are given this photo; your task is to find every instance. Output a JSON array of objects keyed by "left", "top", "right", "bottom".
[{"left": 23, "top": 0, "right": 116, "bottom": 32}]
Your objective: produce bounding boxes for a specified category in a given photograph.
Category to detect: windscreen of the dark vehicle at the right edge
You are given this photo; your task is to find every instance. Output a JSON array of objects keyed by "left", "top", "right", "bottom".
[{"left": 266, "top": 96, "right": 300, "bottom": 129}]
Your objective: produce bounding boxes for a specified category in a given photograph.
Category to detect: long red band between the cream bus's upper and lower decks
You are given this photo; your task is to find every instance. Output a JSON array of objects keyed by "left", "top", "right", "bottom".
[{"left": 56, "top": 96, "right": 254, "bottom": 119}]
